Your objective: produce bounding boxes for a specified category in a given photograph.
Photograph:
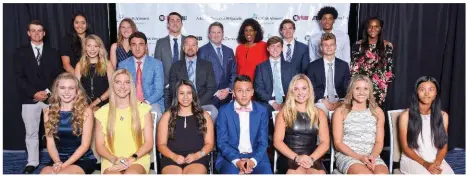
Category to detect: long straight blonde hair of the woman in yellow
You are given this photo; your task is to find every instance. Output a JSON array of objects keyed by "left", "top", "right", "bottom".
[{"left": 106, "top": 69, "right": 143, "bottom": 152}]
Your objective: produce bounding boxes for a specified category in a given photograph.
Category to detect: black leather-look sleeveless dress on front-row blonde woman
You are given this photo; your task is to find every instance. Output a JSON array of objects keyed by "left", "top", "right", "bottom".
[{"left": 277, "top": 112, "right": 324, "bottom": 174}]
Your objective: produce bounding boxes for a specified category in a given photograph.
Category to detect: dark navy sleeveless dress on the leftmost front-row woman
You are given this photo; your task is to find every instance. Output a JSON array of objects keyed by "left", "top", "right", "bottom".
[{"left": 47, "top": 111, "right": 96, "bottom": 174}]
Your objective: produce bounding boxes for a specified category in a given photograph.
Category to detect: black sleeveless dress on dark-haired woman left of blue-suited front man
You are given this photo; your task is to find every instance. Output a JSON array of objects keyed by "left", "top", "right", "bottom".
[{"left": 161, "top": 115, "right": 210, "bottom": 169}]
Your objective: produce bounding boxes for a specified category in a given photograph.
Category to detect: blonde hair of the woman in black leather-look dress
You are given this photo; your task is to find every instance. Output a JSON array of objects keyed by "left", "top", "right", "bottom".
[{"left": 280, "top": 74, "right": 319, "bottom": 128}]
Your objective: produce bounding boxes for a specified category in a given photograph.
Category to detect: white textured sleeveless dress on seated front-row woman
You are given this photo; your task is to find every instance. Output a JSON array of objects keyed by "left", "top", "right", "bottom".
[{"left": 335, "top": 109, "right": 385, "bottom": 174}]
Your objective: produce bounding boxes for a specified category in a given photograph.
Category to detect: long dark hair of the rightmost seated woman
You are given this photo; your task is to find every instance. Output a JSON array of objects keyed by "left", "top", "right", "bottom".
[{"left": 406, "top": 76, "right": 448, "bottom": 149}]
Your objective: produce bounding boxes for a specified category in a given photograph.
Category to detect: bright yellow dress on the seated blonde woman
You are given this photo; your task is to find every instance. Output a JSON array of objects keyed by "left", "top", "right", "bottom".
[{"left": 94, "top": 103, "right": 151, "bottom": 173}]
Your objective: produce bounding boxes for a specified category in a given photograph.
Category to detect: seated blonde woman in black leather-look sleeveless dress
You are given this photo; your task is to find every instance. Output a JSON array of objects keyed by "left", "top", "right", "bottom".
[{"left": 273, "top": 74, "right": 330, "bottom": 174}]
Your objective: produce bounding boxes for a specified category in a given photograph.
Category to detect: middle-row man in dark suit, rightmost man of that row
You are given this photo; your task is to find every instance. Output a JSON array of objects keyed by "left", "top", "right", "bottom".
[{"left": 307, "top": 33, "right": 351, "bottom": 114}]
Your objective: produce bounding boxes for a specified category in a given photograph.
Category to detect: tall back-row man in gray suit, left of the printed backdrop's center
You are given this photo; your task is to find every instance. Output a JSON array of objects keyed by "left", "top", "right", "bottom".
[{"left": 154, "top": 12, "right": 185, "bottom": 88}]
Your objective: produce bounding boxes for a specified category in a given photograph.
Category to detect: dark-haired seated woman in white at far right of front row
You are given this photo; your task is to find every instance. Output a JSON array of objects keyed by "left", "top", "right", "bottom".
[{"left": 398, "top": 76, "right": 455, "bottom": 175}]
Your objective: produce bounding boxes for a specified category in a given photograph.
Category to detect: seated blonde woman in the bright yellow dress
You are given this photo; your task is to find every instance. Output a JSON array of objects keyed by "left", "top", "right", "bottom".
[{"left": 95, "top": 69, "right": 154, "bottom": 174}]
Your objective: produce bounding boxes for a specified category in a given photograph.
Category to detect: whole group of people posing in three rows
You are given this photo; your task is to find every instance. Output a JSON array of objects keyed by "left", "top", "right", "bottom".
[{"left": 14, "top": 7, "right": 453, "bottom": 174}]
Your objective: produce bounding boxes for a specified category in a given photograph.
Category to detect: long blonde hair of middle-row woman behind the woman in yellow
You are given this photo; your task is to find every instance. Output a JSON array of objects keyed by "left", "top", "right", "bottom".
[{"left": 78, "top": 34, "right": 108, "bottom": 76}]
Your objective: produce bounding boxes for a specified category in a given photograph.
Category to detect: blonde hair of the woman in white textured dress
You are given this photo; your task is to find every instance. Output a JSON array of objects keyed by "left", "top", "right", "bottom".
[{"left": 343, "top": 74, "right": 379, "bottom": 117}]
